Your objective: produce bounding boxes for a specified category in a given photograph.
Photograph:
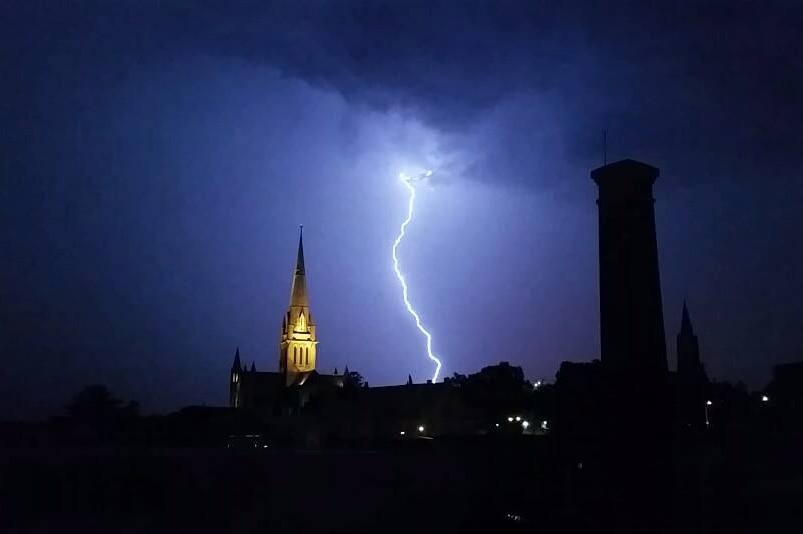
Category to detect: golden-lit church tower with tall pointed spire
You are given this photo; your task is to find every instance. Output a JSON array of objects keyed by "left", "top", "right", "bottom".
[{"left": 279, "top": 227, "right": 318, "bottom": 386}]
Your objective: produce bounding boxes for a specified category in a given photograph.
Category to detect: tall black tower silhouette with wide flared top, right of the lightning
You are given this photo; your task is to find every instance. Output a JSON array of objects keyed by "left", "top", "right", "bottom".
[{"left": 591, "top": 159, "right": 667, "bottom": 383}]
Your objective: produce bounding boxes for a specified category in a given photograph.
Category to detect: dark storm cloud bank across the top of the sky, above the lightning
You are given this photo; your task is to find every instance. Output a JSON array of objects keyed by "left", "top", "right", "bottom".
[{"left": 7, "top": 1, "right": 803, "bottom": 191}]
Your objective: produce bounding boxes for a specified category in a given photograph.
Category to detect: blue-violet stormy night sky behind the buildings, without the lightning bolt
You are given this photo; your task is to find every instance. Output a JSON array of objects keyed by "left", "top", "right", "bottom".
[{"left": 0, "top": 0, "right": 803, "bottom": 417}]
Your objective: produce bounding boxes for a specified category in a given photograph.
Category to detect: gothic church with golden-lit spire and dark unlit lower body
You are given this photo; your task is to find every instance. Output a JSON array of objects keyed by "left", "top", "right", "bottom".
[{"left": 229, "top": 227, "right": 346, "bottom": 416}]
